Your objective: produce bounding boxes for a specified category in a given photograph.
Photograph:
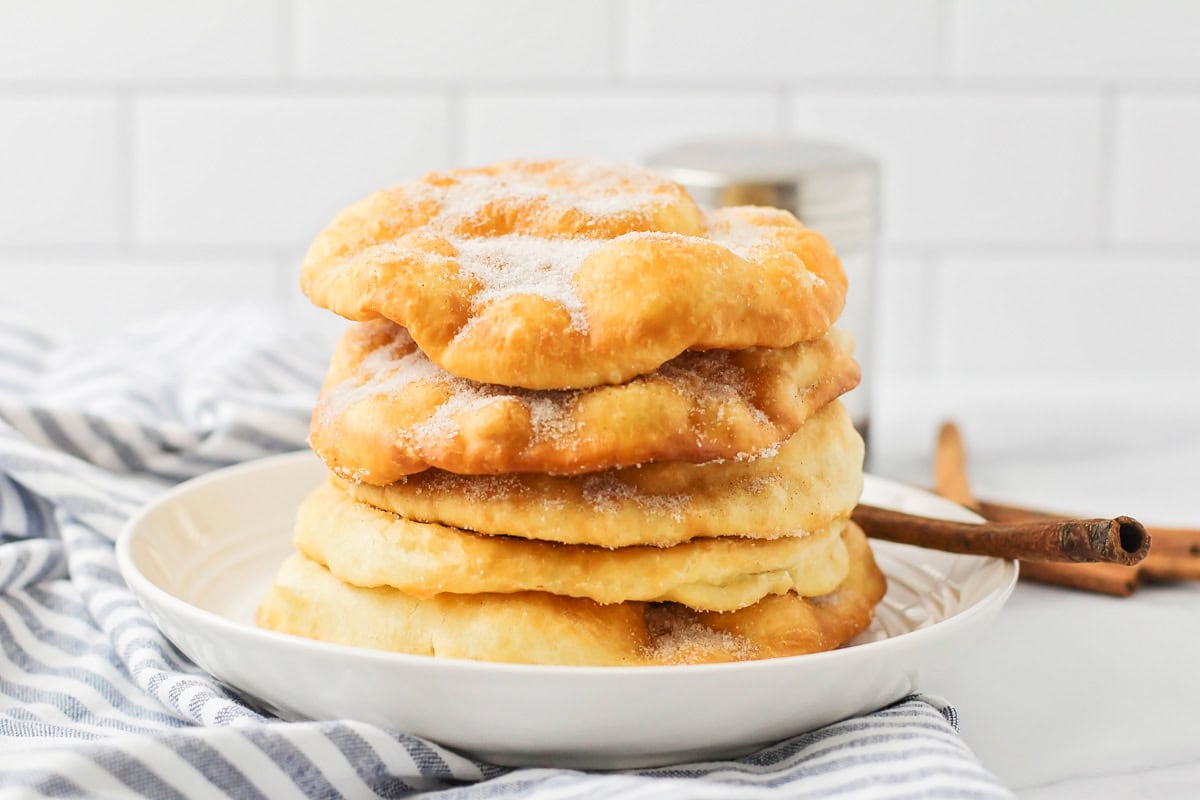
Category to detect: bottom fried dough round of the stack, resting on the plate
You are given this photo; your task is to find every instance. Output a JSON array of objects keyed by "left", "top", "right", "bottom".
[{"left": 257, "top": 524, "right": 887, "bottom": 666}]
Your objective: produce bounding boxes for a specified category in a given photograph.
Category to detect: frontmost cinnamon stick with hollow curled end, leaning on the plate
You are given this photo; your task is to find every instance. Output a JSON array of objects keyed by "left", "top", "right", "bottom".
[{"left": 853, "top": 505, "right": 1150, "bottom": 564}]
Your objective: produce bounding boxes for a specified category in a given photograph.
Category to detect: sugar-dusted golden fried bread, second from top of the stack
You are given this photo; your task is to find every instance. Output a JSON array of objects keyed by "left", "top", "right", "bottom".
[{"left": 310, "top": 320, "right": 859, "bottom": 486}]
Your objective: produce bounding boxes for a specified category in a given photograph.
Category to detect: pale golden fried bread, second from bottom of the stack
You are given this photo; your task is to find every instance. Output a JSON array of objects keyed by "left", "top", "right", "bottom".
[{"left": 294, "top": 483, "right": 848, "bottom": 610}]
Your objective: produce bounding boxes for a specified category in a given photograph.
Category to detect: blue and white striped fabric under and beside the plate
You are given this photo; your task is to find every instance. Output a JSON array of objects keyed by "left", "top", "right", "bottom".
[{"left": 0, "top": 303, "right": 1012, "bottom": 800}]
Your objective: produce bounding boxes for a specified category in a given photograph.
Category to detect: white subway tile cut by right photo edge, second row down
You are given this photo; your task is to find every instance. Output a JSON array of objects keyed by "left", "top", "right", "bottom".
[{"left": 1112, "top": 95, "right": 1200, "bottom": 242}]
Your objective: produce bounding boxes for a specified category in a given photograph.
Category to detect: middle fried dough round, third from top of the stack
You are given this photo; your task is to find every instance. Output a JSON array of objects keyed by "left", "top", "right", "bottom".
[{"left": 332, "top": 401, "right": 863, "bottom": 547}]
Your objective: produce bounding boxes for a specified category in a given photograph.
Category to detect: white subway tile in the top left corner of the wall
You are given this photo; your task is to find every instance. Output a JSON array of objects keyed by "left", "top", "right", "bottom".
[{"left": 0, "top": 0, "right": 281, "bottom": 80}]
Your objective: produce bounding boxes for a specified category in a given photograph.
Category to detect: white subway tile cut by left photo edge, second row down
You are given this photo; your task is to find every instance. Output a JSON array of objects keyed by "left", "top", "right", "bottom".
[{"left": 0, "top": 98, "right": 125, "bottom": 245}]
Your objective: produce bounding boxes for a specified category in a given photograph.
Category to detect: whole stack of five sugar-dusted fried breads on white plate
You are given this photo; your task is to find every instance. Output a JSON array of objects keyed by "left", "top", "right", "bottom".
[{"left": 258, "top": 161, "right": 884, "bottom": 666}]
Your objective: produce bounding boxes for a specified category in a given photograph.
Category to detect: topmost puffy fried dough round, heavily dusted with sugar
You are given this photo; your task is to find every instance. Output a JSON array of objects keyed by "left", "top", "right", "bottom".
[{"left": 301, "top": 161, "right": 846, "bottom": 389}]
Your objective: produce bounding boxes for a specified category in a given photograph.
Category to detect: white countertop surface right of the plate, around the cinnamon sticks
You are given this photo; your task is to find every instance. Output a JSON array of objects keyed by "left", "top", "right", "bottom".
[{"left": 871, "top": 388, "right": 1200, "bottom": 800}]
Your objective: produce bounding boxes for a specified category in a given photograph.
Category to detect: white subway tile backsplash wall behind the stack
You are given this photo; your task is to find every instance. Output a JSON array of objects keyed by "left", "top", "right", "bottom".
[{"left": 0, "top": 0, "right": 1200, "bottom": 462}]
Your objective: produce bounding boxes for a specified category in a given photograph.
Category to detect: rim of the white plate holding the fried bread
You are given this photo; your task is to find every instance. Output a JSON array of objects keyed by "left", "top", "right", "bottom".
[{"left": 115, "top": 450, "right": 1019, "bottom": 678}]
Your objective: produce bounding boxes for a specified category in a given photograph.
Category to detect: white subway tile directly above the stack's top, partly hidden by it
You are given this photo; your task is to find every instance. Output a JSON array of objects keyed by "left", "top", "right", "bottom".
[{"left": 462, "top": 91, "right": 776, "bottom": 164}]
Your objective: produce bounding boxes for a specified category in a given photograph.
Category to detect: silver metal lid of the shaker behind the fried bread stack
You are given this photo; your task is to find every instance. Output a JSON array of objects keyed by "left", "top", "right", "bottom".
[{"left": 646, "top": 138, "right": 880, "bottom": 247}]
